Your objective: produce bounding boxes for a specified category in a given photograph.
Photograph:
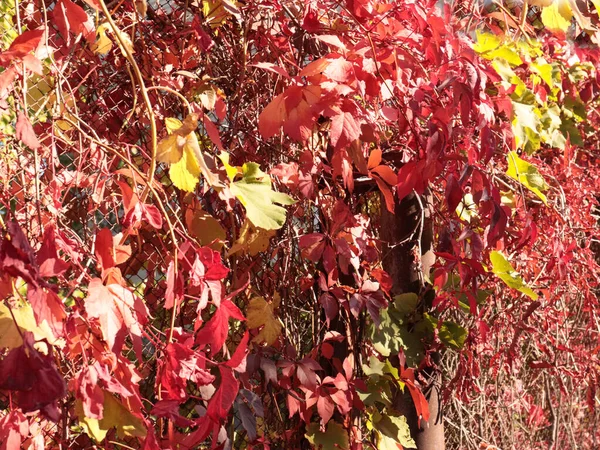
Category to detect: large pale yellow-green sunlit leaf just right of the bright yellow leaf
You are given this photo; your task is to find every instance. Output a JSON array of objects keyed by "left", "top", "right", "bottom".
[{"left": 230, "top": 162, "right": 295, "bottom": 230}]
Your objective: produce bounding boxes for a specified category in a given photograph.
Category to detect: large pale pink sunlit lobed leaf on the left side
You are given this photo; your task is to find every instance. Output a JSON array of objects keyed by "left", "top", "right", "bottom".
[{"left": 84, "top": 278, "right": 148, "bottom": 356}]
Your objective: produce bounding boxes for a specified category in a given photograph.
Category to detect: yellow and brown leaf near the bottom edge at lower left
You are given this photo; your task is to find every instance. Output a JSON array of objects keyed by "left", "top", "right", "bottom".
[{"left": 75, "top": 390, "right": 147, "bottom": 443}]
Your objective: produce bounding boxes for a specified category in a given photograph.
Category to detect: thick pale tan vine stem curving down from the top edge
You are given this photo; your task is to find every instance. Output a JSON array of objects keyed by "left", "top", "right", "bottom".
[{"left": 98, "top": 0, "right": 158, "bottom": 203}]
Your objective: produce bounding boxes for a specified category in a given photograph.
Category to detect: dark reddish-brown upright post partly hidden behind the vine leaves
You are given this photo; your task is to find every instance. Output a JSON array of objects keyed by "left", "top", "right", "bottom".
[{"left": 381, "top": 194, "right": 445, "bottom": 450}]
